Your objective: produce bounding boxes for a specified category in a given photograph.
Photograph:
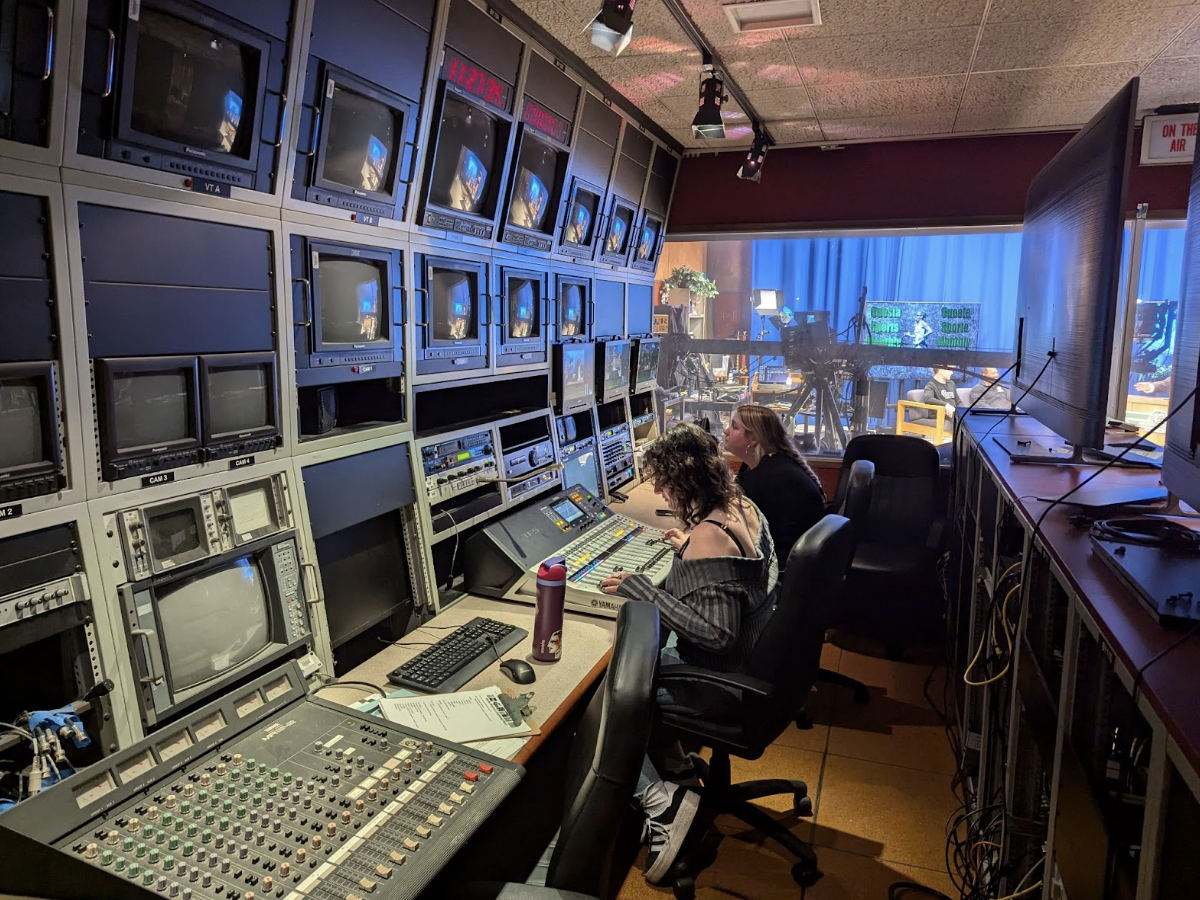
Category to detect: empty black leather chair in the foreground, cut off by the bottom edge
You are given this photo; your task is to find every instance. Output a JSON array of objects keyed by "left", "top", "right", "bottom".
[{"left": 455, "top": 600, "right": 659, "bottom": 900}]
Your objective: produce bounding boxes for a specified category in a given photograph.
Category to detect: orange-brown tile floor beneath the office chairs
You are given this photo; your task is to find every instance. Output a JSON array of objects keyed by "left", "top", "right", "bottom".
[{"left": 620, "top": 646, "right": 956, "bottom": 900}]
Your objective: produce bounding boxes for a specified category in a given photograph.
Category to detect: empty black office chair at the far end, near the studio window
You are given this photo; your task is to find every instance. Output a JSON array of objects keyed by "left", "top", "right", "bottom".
[{"left": 833, "top": 434, "right": 943, "bottom": 659}]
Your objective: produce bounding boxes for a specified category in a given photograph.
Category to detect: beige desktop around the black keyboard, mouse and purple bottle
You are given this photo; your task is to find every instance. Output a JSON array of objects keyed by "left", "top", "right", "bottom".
[{"left": 318, "top": 485, "right": 678, "bottom": 764}]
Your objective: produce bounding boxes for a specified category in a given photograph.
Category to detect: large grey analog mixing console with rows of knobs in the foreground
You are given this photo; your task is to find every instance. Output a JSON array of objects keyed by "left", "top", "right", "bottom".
[{"left": 0, "top": 662, "right": 523, "bottom": 900}]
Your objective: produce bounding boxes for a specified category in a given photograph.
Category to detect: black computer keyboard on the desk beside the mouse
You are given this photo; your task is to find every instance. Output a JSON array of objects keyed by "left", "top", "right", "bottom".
[{"left": 388, "top": 616, "right": 529, "bottom": 694}]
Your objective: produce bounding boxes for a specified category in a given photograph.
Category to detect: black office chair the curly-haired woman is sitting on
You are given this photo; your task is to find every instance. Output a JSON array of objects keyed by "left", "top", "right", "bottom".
[{"left": 659, "top": 515, "right": 854, "bottom": 900}]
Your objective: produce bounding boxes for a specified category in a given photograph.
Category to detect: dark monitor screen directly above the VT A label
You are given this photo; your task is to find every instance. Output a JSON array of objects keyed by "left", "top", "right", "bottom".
[{"left": 130, "top": 6, "right": 260, "bottom": 158}]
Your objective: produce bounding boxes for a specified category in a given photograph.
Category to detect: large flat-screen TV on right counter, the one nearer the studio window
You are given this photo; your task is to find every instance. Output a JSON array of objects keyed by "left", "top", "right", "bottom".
[{"left": 1006, "top": 78, "right": 1138, "bottom": 451}]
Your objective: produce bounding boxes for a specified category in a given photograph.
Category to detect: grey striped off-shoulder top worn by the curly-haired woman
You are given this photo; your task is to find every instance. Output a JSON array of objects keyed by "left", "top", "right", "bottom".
[{"left": 617, "top": 500, "right": 779, "bottom": 672}]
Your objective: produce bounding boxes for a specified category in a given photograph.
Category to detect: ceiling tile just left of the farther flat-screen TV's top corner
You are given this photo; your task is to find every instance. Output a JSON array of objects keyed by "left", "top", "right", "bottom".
[{"left": 962, "top": 62, "right": 1141, "bottom": 109}]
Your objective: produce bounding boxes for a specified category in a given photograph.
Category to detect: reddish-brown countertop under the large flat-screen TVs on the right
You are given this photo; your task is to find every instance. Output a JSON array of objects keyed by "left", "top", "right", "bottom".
[{"left": 964, "top": 415, "right": 1200, "bottom": 770}]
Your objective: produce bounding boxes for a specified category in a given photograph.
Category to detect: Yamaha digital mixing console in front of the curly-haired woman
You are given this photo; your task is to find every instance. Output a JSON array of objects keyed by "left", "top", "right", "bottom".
[{"left": 464, "top": 485, "right": 674, "bottom": 617}]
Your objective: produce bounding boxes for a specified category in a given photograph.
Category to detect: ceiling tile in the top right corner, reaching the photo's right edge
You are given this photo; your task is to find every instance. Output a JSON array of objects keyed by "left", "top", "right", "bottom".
[{"left": 974, "top": 6, "right": 1194, "bottom": 72}]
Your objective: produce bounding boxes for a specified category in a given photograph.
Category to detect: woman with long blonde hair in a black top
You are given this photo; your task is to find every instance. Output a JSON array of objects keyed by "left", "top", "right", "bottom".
[{"left": 725, "top": 404, "right": 826, "bottom": 570}]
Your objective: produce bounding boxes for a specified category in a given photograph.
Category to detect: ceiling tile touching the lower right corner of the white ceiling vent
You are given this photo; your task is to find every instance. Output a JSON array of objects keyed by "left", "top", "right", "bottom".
[{"left": 788, "top": 28, "right": 978, "bottom": 85}]
